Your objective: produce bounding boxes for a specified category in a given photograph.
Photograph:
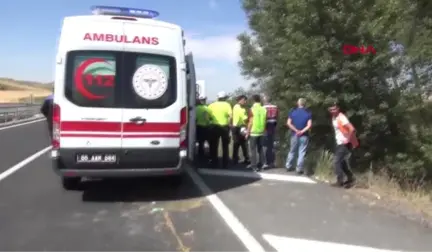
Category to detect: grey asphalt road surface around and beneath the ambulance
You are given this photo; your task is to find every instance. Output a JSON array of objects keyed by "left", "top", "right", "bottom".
[{"left": 0, "top": 122, "right": 432, "bottom": 252}]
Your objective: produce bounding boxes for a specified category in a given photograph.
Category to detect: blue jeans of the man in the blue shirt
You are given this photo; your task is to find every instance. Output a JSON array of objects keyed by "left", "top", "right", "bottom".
[{"left": 285, "top": 135, "right": 309, "bottom": 172}]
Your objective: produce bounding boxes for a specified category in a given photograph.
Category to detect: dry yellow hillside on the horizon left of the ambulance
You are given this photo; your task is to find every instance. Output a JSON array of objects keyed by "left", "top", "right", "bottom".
[{"left": 0, "top": 78, "right": 52, "bottom": 103}]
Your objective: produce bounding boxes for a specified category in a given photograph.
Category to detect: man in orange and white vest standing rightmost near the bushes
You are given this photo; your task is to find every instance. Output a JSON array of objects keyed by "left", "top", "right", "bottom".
[{"left": 329, "top": 103, "right": 359, "bottom": 188}]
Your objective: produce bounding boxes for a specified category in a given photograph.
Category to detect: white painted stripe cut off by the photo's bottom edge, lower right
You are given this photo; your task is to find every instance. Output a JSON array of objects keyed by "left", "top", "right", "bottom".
[{"left": 263, "top": 234, "right": 401, "bottom": 252}]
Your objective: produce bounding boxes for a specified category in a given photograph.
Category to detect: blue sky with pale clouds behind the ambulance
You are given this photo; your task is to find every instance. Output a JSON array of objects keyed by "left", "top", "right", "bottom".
[{"left": 0, "top": 0, "right": 250, "bottom": 99}]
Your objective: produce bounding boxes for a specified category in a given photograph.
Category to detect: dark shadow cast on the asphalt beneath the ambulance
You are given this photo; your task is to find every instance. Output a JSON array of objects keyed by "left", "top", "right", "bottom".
[{"left": 82, "top": 165, "right": 260, "bottom": 202}]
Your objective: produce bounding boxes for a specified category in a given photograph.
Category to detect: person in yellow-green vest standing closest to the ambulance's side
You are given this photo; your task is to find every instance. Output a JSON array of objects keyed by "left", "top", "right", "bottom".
[{"left": 196, "top": 96, "right": 210, "bottom": 161}]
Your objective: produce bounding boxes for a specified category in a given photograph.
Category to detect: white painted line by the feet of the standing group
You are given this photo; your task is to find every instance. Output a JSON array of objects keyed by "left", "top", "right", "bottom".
[{"left": 198, "top": 168, "right": 317, "bottom": 184}]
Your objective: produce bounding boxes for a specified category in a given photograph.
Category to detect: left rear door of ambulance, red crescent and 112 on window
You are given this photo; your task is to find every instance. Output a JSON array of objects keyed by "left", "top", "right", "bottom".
[{"left": 54, "top": 18, "right": 123, "bottom": 157}]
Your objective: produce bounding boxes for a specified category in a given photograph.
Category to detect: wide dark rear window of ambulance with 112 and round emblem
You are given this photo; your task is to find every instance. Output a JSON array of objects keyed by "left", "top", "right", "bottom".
[{"left": 65, "top": 51, "right": 177, "bottom": 109}]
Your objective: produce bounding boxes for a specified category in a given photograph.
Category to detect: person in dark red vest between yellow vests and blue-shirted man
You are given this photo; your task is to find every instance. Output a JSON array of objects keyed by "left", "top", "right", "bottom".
[{"left": 263, "top": 95, "right": 279, "bottom": 169}]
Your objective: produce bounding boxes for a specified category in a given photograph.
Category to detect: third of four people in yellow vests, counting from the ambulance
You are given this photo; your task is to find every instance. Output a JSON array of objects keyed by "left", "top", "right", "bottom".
[{"left": 232, "top": 95, "right": 249, "bottom": 164}]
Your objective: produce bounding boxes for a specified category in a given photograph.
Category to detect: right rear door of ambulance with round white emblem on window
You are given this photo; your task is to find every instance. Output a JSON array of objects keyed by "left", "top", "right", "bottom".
[{"left": 122, "top": 22, "right": 183, "bottom": 168}]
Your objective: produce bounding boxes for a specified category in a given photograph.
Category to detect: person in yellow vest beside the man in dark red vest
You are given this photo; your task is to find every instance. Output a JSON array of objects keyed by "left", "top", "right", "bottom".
[{"left": 246, "top": 95, "right": 267, "bottom": 171}]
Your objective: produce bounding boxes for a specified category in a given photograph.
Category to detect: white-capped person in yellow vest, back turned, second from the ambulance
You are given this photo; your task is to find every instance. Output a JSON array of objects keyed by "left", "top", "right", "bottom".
[{"left": 208, "top": 91, "right": 232, "bottom": 168}]
